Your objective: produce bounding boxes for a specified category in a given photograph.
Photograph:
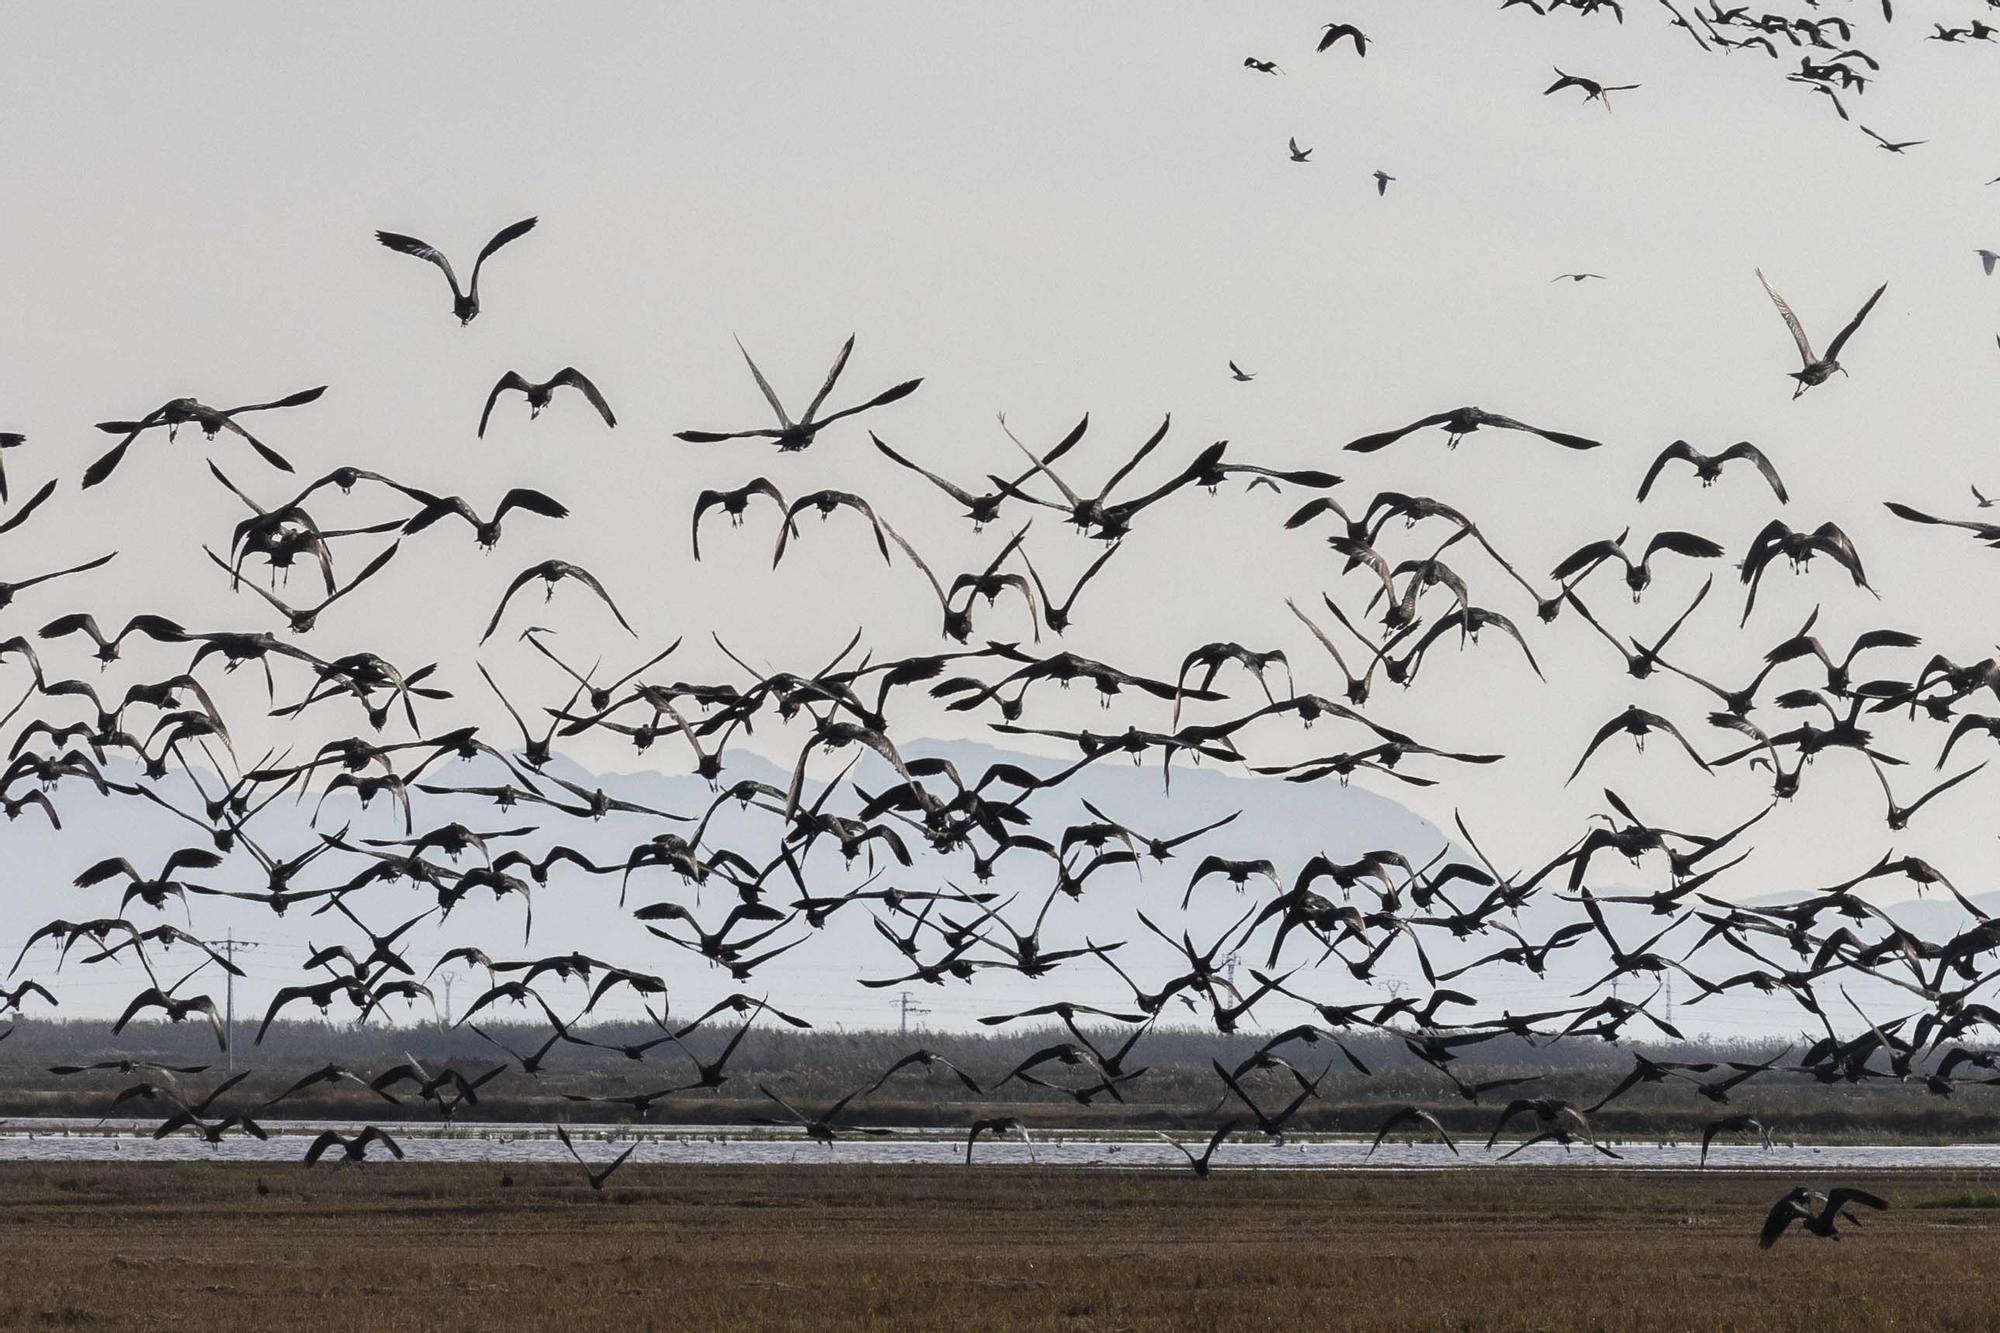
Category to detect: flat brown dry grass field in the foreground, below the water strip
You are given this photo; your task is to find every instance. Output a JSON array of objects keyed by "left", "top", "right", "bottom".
[{"left": 0, "top": 1165, "right": 2000, "bottom": 1329}]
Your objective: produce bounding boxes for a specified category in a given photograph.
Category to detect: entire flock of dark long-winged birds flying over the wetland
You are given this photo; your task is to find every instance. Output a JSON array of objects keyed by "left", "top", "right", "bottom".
[{"left": 0, "top": 0, "right": 2000, "bottom": 1245}]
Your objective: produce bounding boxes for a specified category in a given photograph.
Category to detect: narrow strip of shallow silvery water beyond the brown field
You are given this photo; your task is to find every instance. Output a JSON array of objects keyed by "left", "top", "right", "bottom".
[{"left": 0, "top": 1119, "right": 2000, "bottom": 1171}]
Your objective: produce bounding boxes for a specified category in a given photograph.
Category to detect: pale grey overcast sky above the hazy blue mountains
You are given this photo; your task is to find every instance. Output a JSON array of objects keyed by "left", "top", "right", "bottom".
[{"left": 0, "top": 0, "right": 2000, "bottom": 1024}]
